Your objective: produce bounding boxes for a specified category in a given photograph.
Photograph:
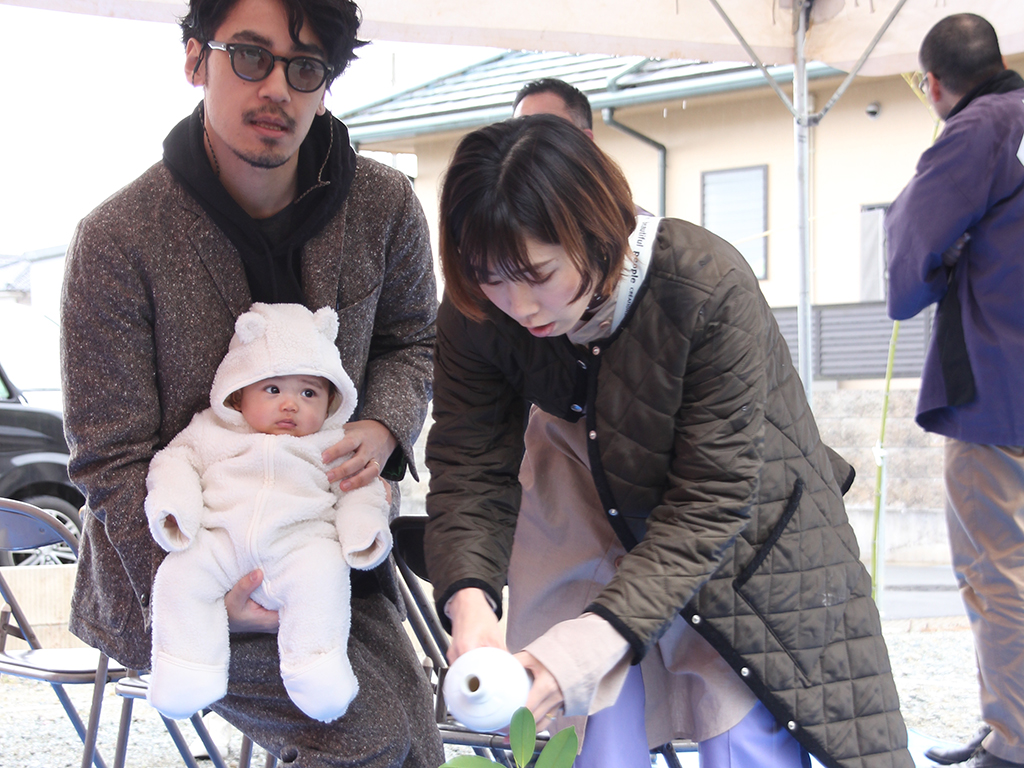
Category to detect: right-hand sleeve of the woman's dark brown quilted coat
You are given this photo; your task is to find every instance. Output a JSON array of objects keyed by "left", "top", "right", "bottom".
[{"left": 589, "top": 269, "right": 767, "bottom": 662}]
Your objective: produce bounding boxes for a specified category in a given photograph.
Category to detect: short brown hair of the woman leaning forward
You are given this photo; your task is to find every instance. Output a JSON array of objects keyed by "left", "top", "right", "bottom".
[{"left": 440, "top": 115, "right": 636, "bottom": 319}]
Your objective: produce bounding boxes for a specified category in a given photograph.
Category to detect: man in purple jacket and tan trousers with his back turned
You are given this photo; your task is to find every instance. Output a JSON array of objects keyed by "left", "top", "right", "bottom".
[{"left": 886, "top": 13, "right": 1024, "bottom": 768}]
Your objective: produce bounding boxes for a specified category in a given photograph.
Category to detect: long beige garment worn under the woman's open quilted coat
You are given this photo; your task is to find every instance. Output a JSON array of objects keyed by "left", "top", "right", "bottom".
[{"left": 507, "top": 408, "right": 757, "bottom": 746}]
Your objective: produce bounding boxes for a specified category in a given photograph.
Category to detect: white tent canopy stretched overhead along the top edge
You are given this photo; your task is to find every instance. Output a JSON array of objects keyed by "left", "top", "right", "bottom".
[{"left": 8, "top": 0, "right": 1024, "bottom": 75}]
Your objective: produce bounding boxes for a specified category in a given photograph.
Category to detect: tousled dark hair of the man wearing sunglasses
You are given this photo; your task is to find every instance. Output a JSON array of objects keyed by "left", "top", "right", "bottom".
[{"left": 179, "top": 0, "right": 367, "bottom": 88}]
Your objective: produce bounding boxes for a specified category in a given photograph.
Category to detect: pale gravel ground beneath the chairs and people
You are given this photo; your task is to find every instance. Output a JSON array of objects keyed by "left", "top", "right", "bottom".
[{"left": 0, "top": 618, "right": 979, "bottom": 768}]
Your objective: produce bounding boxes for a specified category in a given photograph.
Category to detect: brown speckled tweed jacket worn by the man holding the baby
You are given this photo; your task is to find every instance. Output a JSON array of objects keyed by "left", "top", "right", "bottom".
[{"left": 62, "top": 158, "right": 437, "bottom": 669}]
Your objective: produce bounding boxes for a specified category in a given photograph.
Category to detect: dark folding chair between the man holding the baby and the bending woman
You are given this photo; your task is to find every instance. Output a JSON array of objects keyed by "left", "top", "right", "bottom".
[{"left": 391, "top": 515, "right": 696, "bottom": 768}]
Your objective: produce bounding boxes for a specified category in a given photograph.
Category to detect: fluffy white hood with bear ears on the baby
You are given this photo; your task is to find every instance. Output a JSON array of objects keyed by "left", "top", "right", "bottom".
[{"left": 210, "top": 303, "right": 356, "bottom": 427}]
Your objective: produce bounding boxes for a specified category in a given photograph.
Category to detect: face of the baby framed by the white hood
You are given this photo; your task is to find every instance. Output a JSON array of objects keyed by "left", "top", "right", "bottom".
[{"left": 239, "top": 375, "right": 331, "bottom": 437}]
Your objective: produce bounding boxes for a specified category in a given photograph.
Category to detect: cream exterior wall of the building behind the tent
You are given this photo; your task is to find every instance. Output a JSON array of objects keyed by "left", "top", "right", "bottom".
[{"left": 365, "top": 51, "right": 1024, "bottom": 306}]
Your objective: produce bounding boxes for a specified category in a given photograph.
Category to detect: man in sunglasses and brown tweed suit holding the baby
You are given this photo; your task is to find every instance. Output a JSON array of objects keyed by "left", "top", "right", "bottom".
[{"left": 62, "top": 0, "right": 443, "bottom": 768}]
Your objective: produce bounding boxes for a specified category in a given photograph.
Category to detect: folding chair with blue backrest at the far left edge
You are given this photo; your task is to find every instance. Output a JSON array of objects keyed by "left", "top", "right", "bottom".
[{"left": 0, "top": 499, "right": 127, "bottom": 768}]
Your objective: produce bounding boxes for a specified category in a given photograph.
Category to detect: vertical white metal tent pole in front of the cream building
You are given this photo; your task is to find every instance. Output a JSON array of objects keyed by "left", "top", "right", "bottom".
[{"left": 793, "top": 0, "right": 814, "bottom": 409}]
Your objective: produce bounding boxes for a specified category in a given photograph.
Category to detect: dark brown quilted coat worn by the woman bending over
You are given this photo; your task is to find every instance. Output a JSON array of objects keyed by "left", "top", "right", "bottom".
[{"left": 427, "top": 219, "right": 912, "bottom": 768}]
